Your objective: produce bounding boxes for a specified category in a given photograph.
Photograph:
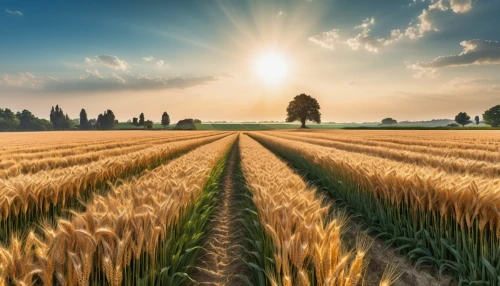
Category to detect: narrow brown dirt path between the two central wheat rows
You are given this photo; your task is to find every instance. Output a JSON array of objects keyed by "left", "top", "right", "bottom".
[{"left": 191, "top": 144, "right": 250, "bottom": 286}]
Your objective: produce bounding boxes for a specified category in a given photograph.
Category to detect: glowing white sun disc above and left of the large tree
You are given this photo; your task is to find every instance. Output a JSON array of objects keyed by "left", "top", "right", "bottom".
[{"left": 255, "top": 51, "right": 288, "bottom": 84}]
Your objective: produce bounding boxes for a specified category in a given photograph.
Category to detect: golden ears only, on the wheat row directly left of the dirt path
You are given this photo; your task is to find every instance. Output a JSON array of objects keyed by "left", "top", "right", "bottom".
[{"left": 0, "top": 135, "right": 235, "bottom": 286}]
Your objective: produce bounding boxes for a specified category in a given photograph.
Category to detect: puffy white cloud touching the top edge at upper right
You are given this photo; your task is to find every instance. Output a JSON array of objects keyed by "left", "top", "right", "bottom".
[{"left": 405, "top": 0, "right": 473, "bottom": 40}]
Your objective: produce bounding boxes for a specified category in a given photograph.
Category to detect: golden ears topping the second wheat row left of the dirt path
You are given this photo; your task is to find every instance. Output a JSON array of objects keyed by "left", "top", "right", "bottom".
[{"left": 0, "top": 134, "right": 227, "bottom": 223}]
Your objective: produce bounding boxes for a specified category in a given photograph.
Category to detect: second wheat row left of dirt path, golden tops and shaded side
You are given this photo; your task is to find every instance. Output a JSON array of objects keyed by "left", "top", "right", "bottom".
[{"left": 0, "top": 133, "right": 228, "bottom": 242}]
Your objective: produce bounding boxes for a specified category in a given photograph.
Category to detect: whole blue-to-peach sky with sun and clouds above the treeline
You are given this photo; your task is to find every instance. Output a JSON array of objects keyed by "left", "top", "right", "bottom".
[{"left": 0, "top": 0, "right": 500, "bottom": 122}]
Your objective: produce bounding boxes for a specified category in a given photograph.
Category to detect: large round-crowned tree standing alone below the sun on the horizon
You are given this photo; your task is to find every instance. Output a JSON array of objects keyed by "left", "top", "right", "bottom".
[{"left": 286, "top": 93, "right": 321, "bottom": 128}]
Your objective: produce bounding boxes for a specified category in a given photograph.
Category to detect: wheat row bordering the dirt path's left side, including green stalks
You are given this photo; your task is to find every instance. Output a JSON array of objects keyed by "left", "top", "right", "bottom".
[{"left": 0, "top": 136, "right": 235, "bottom": 286}]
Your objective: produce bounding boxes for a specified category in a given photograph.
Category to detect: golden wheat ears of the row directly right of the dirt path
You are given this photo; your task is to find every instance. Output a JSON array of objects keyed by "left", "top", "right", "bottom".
[{"left": 240, "top": 136, "right": 368, "bottom": 286}]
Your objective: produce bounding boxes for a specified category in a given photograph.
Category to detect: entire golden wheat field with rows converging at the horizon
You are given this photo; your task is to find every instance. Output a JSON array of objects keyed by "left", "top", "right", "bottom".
[{"left": 0, "top": 131, "right": 500, "bottom": 286}]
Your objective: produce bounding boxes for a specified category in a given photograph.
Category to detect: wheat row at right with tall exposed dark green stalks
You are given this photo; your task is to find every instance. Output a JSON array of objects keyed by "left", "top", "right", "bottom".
[{"left": 251, "top": 133, "right": 500, "bottom": 285}]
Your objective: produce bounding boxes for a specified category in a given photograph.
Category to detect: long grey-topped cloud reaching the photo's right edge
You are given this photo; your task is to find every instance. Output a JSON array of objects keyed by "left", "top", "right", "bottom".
[{"left": 407, "top": 40, "right": 500, "bottom": 76}]
